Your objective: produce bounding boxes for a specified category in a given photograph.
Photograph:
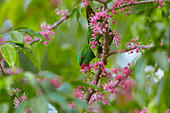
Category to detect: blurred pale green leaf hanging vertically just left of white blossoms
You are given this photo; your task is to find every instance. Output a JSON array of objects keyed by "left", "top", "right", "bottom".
[{"left": 135, "top": 56, "right": 146, "bottom": 89}]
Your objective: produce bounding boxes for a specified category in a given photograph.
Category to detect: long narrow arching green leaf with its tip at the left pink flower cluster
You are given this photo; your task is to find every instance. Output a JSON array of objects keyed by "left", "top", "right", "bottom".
[{"left": 14, "top": 27, "right": 48, "bottom": 41}]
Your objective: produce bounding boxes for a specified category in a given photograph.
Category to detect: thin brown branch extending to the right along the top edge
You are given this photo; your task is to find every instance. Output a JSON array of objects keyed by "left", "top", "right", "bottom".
[{"left": 109, "top": 0, "right": 170, "bottom": 12}]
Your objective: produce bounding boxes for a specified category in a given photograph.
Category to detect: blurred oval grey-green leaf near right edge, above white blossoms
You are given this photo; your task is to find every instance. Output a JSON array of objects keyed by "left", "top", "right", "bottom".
[{"left": 153, "top": 50, "right": 168, "bottom": 71}]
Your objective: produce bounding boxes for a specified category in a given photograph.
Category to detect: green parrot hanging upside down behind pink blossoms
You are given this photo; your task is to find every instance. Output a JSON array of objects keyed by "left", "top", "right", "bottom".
[{"left": 78, "top": 6, "right": 113, "bottom": 69}]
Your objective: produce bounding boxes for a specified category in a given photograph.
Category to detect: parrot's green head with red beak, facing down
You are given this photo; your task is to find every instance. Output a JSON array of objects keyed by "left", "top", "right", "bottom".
[{"left": 78, "top": 44, "right": 95, "bottom": 69}]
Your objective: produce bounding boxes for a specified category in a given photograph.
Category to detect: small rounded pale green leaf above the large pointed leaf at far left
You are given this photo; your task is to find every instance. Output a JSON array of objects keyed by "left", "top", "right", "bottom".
[{"left": 11, "top": 31, "right": 24, "bottom": 42}]
